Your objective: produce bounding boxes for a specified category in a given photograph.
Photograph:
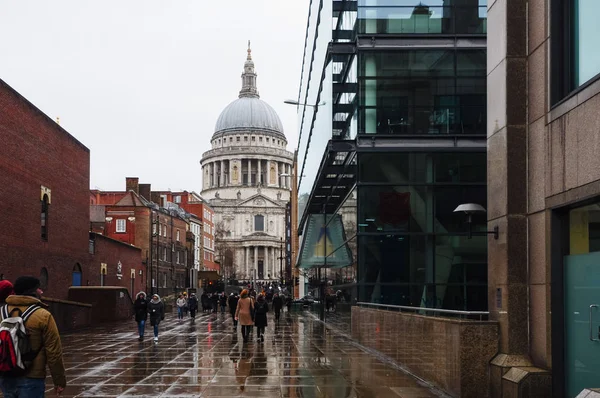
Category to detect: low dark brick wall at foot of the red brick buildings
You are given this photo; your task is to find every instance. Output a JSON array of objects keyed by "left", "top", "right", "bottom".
[{"left": 69, "top": 286, "right": 134, "bottom": 325}]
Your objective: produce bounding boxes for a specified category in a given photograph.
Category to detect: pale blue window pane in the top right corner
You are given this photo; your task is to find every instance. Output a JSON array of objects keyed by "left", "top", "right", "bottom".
[{"left": 573, "top": 0, "right": 600, "bottom": 87}]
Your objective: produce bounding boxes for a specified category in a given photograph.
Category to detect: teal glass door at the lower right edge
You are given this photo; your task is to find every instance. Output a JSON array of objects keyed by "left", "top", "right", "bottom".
[{"left": 564, "top": 252, "right": 600, "bottom": 397}]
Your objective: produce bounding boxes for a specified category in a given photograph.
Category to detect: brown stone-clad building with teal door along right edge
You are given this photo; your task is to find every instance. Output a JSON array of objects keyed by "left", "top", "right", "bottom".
[{"left": 487, "top": 0, "right": 600, "bottom": 397}]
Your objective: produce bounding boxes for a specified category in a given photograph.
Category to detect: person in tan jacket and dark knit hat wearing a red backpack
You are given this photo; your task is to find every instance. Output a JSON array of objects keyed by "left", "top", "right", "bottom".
[{"left": 0, "top": 276, "right": 67, "bottom": 398}]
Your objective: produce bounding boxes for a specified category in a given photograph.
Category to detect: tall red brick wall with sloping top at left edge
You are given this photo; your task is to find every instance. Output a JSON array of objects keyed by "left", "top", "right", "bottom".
[{"left": 0, "top": 80, "right": 90, "bottom": 298}]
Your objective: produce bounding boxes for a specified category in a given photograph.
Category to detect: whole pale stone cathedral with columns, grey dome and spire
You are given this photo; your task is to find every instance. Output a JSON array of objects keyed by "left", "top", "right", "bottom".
[{"left": 200, "top": 46, "right": 293, "bottom": 281}]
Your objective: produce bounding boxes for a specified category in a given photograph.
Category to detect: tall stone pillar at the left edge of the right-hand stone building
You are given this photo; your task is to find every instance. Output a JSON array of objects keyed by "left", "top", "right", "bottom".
[{"left": 488, "top": 0, "right": 546, "bottom": 388}]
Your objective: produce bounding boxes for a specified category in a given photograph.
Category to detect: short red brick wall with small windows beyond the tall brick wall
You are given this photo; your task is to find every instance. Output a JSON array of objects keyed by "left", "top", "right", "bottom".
[{"left": 89, "top": 234, "right": 146, "bottom": 297}]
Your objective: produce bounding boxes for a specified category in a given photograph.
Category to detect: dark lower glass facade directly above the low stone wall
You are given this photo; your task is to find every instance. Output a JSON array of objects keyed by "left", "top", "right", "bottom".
[{"left": 357, "top": 151, "right": 487, "bottom": 310}]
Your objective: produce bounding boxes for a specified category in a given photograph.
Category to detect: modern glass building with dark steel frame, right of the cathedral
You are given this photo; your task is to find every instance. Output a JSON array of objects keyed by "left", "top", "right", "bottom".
[{"left": 296, "top": 0, "right": 488, "bottom": 320}]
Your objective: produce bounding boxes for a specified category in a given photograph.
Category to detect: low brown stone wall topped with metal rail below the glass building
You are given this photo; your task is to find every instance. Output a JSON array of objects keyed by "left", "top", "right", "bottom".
[{"left": 352, "top": 307, "right": 498, "bottom": 398}]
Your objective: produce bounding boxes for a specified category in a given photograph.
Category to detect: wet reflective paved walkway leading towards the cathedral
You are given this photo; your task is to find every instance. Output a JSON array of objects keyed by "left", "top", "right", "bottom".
[{"left": 47, "top": 314, "right": 440, "bottom": 398}]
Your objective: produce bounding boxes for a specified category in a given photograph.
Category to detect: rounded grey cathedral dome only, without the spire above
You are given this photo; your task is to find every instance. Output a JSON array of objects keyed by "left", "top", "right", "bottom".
[{"left": 215, "top": 97, "right": 283, "bottom": 134}]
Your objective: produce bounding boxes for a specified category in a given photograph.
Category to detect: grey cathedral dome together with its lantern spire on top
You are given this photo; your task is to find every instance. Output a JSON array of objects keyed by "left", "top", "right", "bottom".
[{"left": 213, "top": 42, "right": 285, "bottom": 139}]
